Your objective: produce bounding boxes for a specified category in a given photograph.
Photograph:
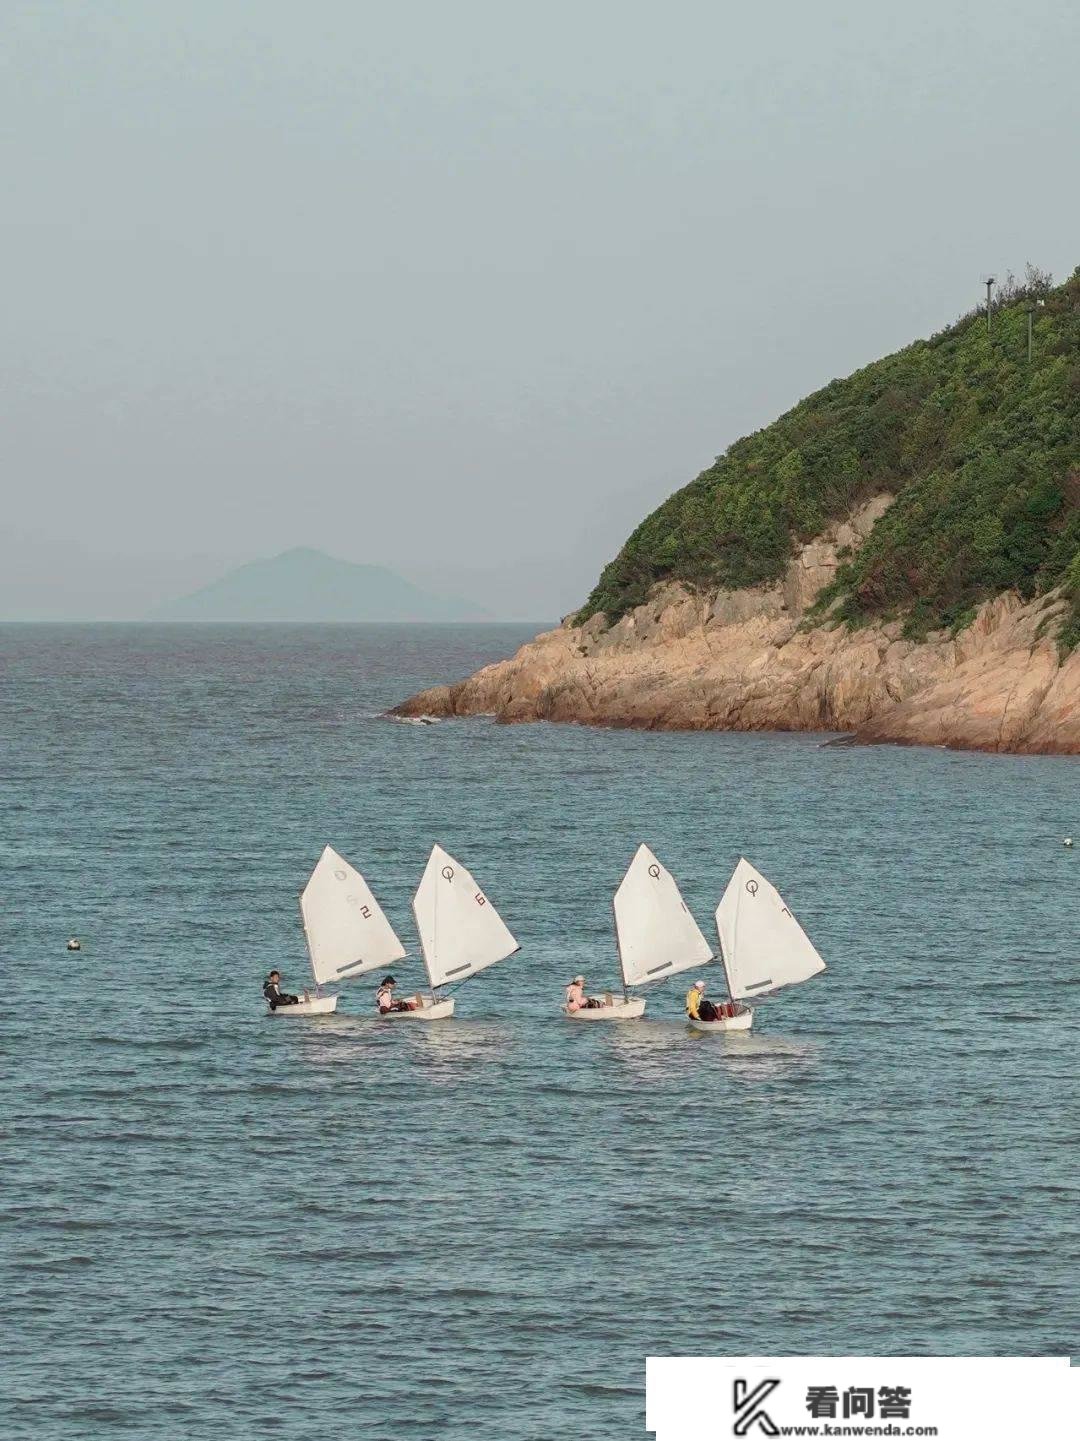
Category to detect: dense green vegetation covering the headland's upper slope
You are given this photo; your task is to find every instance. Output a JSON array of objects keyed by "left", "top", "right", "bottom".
[{"left": 580, "top": 267, "right": 1080, "bottom": 646}]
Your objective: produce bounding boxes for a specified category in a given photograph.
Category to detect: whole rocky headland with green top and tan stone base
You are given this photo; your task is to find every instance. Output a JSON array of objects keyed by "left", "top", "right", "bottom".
[{"left": 401, "top": 265, "right": 1080, "bottom": 754}]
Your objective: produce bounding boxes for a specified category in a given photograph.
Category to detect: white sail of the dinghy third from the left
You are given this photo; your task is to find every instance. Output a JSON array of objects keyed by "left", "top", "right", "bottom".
[{"left": 614, "top": 846, "right": 712, "bottom": 986}]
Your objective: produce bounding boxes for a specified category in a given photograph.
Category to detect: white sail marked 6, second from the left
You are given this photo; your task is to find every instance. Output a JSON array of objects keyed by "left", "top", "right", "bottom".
[{"left": 412, "top": 846, "right": 518, "bottom": 990}]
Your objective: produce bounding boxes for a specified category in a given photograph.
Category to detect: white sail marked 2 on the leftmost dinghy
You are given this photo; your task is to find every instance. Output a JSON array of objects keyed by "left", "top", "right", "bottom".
[{"left": 300, "top": 846, "right": 405, "bottom": 986}]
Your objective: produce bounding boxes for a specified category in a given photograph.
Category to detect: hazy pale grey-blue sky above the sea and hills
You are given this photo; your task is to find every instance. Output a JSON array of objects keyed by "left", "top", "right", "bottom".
[{"left": 0, "top": 0, "right": 1080, "bottom": 620}]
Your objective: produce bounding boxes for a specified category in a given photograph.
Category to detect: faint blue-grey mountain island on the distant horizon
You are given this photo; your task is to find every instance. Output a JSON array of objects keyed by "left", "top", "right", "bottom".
[{"left": 151, "top": 546, "right": 490, "bottom": 621}]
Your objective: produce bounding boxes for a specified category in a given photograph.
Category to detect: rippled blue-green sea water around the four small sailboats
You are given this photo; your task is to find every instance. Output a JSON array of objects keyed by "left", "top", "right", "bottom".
[{"left": 0, "top": 627, "right": 1080, "bottom": 1441}]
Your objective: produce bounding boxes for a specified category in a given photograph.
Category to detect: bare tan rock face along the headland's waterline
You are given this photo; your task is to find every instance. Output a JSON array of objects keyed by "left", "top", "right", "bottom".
[{"left": 397, "top": 496, "right": 1080, "bottom": 754}]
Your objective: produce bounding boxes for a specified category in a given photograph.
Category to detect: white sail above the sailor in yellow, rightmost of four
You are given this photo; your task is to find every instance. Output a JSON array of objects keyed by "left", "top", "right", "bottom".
[{"left": 717, "top": 860, "right": 825, "bottom": 1000}]
